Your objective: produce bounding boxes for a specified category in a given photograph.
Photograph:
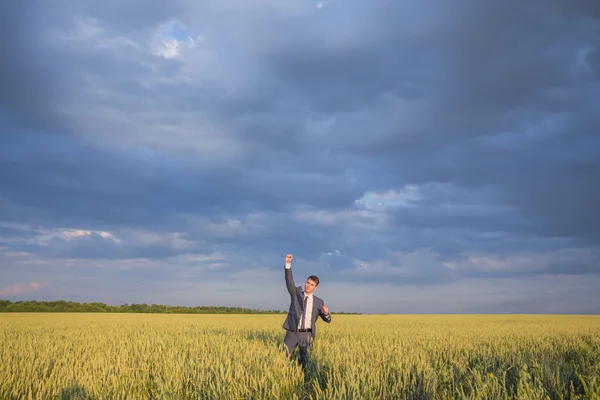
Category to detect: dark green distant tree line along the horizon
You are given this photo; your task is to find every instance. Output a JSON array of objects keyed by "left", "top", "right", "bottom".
[{"left": 0, "top": 300, "right": 356, "bottom": 314}]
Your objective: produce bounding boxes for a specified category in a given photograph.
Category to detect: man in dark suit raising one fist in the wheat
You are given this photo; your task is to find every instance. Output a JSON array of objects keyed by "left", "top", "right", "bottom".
[{"left": 283, "top": 254, "right": 331, "bottom": 369}]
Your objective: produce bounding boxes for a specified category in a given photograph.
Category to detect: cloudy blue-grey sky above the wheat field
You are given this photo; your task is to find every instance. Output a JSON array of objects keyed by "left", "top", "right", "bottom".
[{"left": 0, "top": 0, "right": 600, "bottom": 314}]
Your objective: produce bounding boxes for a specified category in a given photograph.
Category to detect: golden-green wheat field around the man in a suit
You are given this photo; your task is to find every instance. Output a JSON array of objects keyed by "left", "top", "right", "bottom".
[{"left": 0, "top": 313, "right": 600, "bottom": 399}]
